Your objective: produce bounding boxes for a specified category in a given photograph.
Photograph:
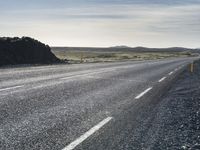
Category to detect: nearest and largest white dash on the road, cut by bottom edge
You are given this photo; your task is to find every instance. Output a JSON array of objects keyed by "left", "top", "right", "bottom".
[{"left": 62, "top": 117, "right": 112, "bottom": 150}]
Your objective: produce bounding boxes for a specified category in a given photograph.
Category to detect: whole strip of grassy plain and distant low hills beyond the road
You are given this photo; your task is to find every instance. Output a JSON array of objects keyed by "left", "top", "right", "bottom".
[{"left": 51, "top": 46, "right": 199, "bottom": 63}]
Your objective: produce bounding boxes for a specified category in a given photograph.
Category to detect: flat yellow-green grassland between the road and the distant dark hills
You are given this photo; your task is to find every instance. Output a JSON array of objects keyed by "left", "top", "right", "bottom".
[{"left": 53, "top": 50, "right": 194, "bottom": 63}]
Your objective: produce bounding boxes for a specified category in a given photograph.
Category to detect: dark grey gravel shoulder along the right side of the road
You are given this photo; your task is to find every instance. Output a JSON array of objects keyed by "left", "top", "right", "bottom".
[{"left": 142, "top": 61, "right": 200, "bottom": 150}]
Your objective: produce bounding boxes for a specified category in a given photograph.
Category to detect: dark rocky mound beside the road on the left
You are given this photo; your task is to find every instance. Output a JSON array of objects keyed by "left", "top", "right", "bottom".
[{"left": 0, "top": 37, "right": 61, "bottom": 66}]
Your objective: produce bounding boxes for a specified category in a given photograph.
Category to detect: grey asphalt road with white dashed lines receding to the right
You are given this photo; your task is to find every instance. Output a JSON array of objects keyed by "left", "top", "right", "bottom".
[{"left": 0, "top": 58, "right": 197, "bottom": 150}]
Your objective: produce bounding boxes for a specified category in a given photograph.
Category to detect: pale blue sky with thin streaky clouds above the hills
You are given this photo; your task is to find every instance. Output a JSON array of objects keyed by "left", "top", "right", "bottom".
[{"left": 0, "top": 0, "right": 200, "bottom": 48}]
